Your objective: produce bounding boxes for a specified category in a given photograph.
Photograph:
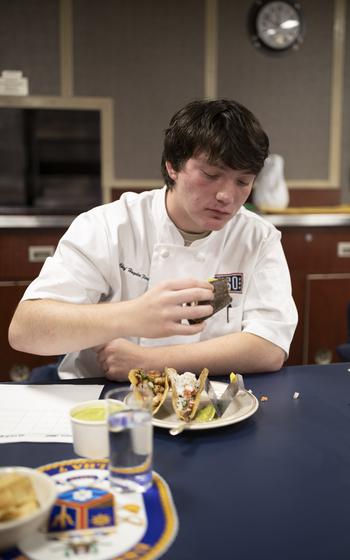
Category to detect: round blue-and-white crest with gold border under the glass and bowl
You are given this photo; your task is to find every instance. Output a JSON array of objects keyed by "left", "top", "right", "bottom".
[{"left": 5, "top": 459, "right": 178, "bottom": 560}]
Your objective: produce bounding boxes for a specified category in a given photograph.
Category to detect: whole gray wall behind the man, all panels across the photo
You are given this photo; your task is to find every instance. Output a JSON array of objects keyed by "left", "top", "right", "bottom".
[{"left": 0, "top": 0, "right": 350, "bottom": 201}]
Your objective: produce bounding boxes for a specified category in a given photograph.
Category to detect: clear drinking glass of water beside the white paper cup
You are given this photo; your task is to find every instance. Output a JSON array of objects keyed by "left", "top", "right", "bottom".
[{"left": 105, "top": 387, "right": 153, "bottom": 493}]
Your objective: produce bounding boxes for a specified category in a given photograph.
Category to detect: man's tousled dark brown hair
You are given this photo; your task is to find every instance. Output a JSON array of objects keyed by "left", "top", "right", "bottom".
[{"left": 161, "top": 99, "right": 269, "bottom": 188}]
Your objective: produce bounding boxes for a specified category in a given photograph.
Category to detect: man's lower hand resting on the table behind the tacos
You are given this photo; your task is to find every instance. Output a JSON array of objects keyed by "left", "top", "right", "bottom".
[{"left": 97, "top": 338, "right": 152, "bottom": 381}]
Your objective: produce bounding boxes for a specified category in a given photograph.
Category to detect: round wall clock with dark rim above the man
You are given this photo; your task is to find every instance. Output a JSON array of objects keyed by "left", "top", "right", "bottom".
[{"left": 249, "top": 0, "right": 304, "bottom": 54}]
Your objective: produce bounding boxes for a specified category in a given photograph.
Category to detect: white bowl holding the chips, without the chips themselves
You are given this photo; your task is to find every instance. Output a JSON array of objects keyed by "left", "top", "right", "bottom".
[{"left": 0, "top": 467, "right": 57, "bottom": 550}]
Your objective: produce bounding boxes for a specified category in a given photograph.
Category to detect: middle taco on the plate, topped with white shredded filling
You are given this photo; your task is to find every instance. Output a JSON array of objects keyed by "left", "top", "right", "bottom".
[{"left": 165, "top": 368, "right": 209, "bottom": 422}]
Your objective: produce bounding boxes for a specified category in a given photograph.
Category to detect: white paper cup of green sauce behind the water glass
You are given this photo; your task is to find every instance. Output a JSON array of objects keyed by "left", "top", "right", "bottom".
[{"left": 70, "top": 400, "right": 109, "bottom": 459}]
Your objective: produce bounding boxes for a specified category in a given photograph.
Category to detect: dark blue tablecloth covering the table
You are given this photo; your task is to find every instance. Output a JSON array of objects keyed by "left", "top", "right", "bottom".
[{"left": 0, "top": 363, "right": 350, "bottom": 560}]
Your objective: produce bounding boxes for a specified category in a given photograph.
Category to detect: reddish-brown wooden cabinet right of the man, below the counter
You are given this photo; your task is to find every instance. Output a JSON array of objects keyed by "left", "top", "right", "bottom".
[{"left": 278, "top": 226, "right": 350, "bottom": 365}]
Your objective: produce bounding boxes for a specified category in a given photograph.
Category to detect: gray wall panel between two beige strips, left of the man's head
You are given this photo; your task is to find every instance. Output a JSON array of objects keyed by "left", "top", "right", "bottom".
[{"left": 73, "top": 0, "right": 204, "bottom": 179}]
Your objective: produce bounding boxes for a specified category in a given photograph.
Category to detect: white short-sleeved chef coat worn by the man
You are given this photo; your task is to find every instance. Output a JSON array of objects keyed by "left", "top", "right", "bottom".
[{"left": 23, "top": 187, "right": 297, "bottom": 379}]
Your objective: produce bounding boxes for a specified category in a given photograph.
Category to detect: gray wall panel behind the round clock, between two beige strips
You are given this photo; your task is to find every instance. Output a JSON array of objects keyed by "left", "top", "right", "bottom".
[{"left": 218, "top": 0, "right": 333, "bottom": 179}]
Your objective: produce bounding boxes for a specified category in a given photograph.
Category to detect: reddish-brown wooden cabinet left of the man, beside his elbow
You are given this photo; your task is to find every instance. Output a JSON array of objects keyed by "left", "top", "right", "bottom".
[{"left": 0, "top": 228, "right": 64, "bottom": 381}]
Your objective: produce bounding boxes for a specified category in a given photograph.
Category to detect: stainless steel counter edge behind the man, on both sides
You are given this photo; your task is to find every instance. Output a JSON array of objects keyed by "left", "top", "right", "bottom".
[{"left": 0, "top": 214, "right": 350, "bottom": 228}]
